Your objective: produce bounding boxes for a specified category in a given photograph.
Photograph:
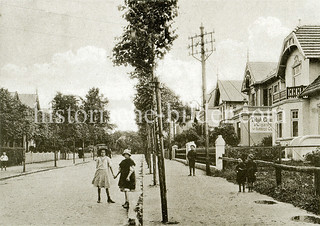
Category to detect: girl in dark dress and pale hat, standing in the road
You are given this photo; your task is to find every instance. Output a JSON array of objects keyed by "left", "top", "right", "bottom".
[{"left": 114, "top": 149, "right": 136, "bottom": 209}]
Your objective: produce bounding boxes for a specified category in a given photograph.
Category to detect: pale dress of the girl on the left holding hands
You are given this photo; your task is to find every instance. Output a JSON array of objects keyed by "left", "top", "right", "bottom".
[{"left": 92, "top": 156, "right": 111, "bottom": 188}]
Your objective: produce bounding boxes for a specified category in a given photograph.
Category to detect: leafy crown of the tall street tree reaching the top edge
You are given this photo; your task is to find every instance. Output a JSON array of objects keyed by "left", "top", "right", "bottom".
[{"left": 113, "top": 0, "right": 177, "bottom": 140}]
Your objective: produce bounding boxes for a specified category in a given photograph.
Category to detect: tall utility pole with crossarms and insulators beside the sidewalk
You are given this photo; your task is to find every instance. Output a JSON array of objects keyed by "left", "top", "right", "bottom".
[{"left": 188, "top": 24, "right": 215, "bottom": 176}]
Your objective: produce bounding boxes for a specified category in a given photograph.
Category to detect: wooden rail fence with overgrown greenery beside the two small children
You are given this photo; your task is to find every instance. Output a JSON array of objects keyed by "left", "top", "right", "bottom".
[{"left": 218, "top": 147, "right": 320, "bottom": 214}]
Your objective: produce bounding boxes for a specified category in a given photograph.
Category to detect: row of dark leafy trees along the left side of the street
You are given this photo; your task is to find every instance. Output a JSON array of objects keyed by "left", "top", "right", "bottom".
[{"left": 0, "top": 88, "right": 142, "bottom": 153}]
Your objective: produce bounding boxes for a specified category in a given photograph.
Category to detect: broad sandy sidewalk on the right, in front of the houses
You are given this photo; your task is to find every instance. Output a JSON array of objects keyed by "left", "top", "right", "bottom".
[{"left": 143, "top": 160, "right": 315, "bottom": 226}]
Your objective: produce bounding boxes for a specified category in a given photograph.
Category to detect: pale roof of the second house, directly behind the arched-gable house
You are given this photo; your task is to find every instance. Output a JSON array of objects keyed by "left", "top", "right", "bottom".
[{"left": 246, "top": 62, "right": 278, "bottom": 84}]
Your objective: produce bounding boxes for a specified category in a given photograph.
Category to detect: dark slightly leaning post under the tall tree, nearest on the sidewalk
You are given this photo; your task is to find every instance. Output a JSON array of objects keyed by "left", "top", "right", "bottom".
[{"left": 153, "top": 77, "right": 168, "bottom": 223}]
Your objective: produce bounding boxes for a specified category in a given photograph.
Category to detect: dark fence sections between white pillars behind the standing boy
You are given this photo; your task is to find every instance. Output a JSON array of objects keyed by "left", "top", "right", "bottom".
[{"left": 174, "top": 147, "right": 216, "bottom": 166}]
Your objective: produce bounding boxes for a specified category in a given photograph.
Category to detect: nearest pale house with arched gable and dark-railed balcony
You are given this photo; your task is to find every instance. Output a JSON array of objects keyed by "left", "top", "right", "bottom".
[{"left": 272, "top": 26, "right": 320, "bottom": 145}]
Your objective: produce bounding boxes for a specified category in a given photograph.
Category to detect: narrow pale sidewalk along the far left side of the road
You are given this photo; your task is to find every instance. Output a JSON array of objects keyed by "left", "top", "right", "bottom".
[{"left": 0, "top": 158, "right": 92, "bottom": 180}]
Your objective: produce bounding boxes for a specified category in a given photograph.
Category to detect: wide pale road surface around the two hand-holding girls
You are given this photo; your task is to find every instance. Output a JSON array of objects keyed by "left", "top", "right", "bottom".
[{"left": 0, "top": 156, "right": 141, "bottom": 225}]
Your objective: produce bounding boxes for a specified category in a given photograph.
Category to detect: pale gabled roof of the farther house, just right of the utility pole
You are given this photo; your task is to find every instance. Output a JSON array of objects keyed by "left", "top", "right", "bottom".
[{"left": 209, "top": 80, "right": 246, "bottom": 107}]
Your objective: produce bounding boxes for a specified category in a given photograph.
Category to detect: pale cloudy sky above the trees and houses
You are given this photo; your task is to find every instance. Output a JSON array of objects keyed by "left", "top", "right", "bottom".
[{"left": 0, "top": 0, "right": 320, "bottom": 130}]
